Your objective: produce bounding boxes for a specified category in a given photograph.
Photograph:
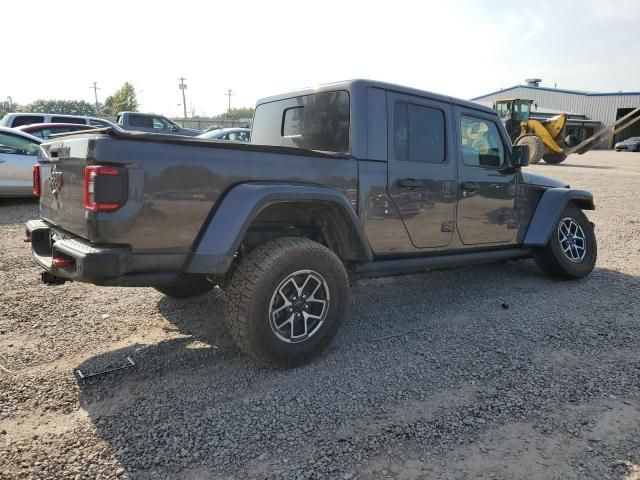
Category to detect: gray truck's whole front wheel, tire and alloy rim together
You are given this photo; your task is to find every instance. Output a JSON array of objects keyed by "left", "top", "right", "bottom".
[{"left": 533, "top": 204, "right": 598, "bottom": 279}]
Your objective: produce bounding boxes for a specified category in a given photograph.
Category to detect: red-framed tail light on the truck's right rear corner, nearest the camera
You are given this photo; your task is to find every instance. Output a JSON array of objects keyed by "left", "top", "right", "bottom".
[{"left": 84, "top": 165, "right": 125, "bottom": 212}]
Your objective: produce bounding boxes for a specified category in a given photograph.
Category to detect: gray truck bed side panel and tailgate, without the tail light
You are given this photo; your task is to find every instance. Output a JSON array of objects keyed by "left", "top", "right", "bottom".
[{"left": 39, "top": 128, "right": 357, "bottom": 269}]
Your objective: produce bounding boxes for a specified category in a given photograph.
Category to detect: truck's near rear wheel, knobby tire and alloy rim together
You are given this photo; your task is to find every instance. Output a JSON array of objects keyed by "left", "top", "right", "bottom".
[{"left": 225, "top": 237, "right": 349, "bottom": 367}]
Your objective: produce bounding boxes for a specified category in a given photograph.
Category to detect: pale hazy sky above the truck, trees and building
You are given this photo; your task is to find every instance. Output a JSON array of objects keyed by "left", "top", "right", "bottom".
[{"left": 0, "top": 0, "right": 640, "bottom": 115}]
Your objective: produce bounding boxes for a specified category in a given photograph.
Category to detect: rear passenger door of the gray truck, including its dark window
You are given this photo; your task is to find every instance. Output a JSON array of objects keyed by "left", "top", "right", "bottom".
[{"left": 387, "top": 93, "right": 456, "bottom": 248}]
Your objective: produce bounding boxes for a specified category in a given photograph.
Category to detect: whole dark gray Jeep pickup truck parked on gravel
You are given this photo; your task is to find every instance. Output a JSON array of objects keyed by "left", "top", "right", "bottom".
[{"left": 26, "top": 80, "right": 597, "bottom": 366}]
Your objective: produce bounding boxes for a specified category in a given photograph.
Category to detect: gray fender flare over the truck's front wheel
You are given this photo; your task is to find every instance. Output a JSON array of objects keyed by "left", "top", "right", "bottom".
[{"left": 523, "top": 188, "right": 595, "bottom": 247}]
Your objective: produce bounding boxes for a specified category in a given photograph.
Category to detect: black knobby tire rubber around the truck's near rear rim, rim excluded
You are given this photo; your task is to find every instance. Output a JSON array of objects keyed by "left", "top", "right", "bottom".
[{"left": 225, "top": 237, "right": 350, "bottom": 368}]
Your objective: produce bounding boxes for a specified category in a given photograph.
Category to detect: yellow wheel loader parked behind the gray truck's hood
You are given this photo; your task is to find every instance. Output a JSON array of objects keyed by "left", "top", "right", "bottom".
[{"left": 493, "top": 98, "right": 579, "bottom": 164}]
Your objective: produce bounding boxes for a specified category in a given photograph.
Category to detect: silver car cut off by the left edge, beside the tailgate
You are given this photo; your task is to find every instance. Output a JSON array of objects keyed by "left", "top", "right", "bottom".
[{"left": 0, "top": 127, "right": 42, "bottom": 197}]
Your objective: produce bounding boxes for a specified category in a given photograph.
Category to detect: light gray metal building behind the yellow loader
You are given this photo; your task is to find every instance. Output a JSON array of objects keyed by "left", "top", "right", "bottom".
[{"left": 472, "top": 78, "right": 640, "bottom": 148}]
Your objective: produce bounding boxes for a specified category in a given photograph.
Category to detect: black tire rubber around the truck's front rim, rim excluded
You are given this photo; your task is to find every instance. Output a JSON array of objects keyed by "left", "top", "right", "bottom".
[{"left": 533, "top": 204, "right": 598, "bottom": 279}]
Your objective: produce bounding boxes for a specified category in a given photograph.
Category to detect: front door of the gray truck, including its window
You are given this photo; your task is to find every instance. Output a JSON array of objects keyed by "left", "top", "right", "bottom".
[{"left": 456, "top": 108, "right": 518, "bottom": 245}]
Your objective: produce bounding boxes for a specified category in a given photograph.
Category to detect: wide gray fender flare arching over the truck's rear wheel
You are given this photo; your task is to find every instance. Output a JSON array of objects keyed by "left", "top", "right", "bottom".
[{"left": 186, "top": 182, "right": 373, "bottom": 275}]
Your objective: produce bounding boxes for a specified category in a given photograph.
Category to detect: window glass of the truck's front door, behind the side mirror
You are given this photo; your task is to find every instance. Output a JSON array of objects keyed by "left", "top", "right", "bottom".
[{"left": 460, "top": 115, "right": 504, "bottom": 168}]
